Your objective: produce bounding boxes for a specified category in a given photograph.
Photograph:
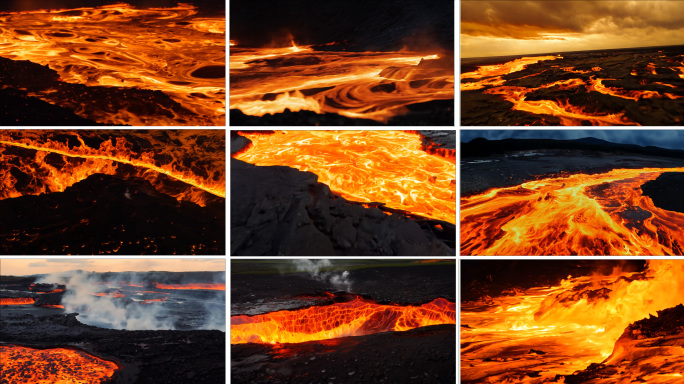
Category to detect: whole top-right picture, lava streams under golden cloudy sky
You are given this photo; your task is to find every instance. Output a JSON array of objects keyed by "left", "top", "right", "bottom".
[{"left": 460, "top": 0, "right": 684, "bottom": 126}]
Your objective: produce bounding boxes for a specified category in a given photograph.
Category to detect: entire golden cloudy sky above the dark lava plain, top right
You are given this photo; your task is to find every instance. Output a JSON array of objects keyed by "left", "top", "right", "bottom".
[{"left": 461, "top": 0, "right": 684, "bottom": 58}]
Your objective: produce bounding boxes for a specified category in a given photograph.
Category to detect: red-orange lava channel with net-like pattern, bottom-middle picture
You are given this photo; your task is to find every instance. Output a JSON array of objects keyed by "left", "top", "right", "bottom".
[{"left": 230, "top": 297, "right": 456, "bottom": 344}]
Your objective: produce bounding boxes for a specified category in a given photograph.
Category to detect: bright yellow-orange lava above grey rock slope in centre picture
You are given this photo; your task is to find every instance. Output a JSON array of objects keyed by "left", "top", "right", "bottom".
[{"left": 234, "top": 131, "right": 456, "bottom": 224}]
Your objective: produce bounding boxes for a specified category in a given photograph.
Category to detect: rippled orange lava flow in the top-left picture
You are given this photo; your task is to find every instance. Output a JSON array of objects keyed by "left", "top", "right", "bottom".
[{"left": 0, "top": 3, "right": 226, "bottom": 125}]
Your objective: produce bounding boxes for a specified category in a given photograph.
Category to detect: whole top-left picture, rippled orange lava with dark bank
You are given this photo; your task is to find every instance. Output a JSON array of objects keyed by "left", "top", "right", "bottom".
[{"left": 0, "top": 0, "right": 226, "bottom": 126}]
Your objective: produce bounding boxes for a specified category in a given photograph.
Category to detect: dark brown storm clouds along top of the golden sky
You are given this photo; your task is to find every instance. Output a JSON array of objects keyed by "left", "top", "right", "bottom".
[{"left": 461, "top": 0, "right": 684, "bottom": 39}]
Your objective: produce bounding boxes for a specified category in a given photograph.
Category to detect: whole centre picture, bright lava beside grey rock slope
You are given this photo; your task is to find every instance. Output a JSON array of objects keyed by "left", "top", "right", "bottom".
[{"left": 231, "top": 130, "right": 456, "bottom": 256}]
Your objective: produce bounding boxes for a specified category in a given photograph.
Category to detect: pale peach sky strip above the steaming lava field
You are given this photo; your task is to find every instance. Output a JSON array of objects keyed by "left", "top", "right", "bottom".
[{"left": 0, "top": 258, "right": 226, "bottom": 276}]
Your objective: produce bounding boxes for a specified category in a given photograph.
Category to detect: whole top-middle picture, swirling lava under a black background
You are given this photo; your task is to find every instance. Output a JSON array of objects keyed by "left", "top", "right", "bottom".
[{"left": 229, "top": 0, "right": 455, "bottom": 126}]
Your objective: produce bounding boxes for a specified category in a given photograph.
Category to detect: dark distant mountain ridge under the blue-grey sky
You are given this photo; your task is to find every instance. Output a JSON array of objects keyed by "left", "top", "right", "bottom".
[{"left": 461, "top": 137, "right": 684, "bottom": 159}]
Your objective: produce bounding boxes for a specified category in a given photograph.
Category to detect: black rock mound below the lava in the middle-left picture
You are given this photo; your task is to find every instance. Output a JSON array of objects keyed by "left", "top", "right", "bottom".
[{"left": 0, "top": 174, "right": 225, "bottom": 255}]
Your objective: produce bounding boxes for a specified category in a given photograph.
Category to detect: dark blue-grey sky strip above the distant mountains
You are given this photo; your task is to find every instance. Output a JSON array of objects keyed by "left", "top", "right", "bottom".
[{"left": 461, "top": 129, "right": 684, "bottom": 150}]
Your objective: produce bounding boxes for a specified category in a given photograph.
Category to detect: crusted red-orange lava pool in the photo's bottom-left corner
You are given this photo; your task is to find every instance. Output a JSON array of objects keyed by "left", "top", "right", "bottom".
[{"left": 0, "top": 345, "right": 118, "bottom": 384}]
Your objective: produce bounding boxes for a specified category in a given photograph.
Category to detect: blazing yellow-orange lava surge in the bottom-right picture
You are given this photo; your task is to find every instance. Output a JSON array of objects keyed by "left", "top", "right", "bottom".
[{"left": 460, "top": 260, "right": 684, "bottom": 384}]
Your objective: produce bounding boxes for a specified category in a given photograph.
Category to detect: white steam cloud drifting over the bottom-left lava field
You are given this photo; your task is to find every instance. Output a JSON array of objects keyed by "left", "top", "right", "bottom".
[{"left": 36, "top": 271, "right": 225, "bottom": 331}]
